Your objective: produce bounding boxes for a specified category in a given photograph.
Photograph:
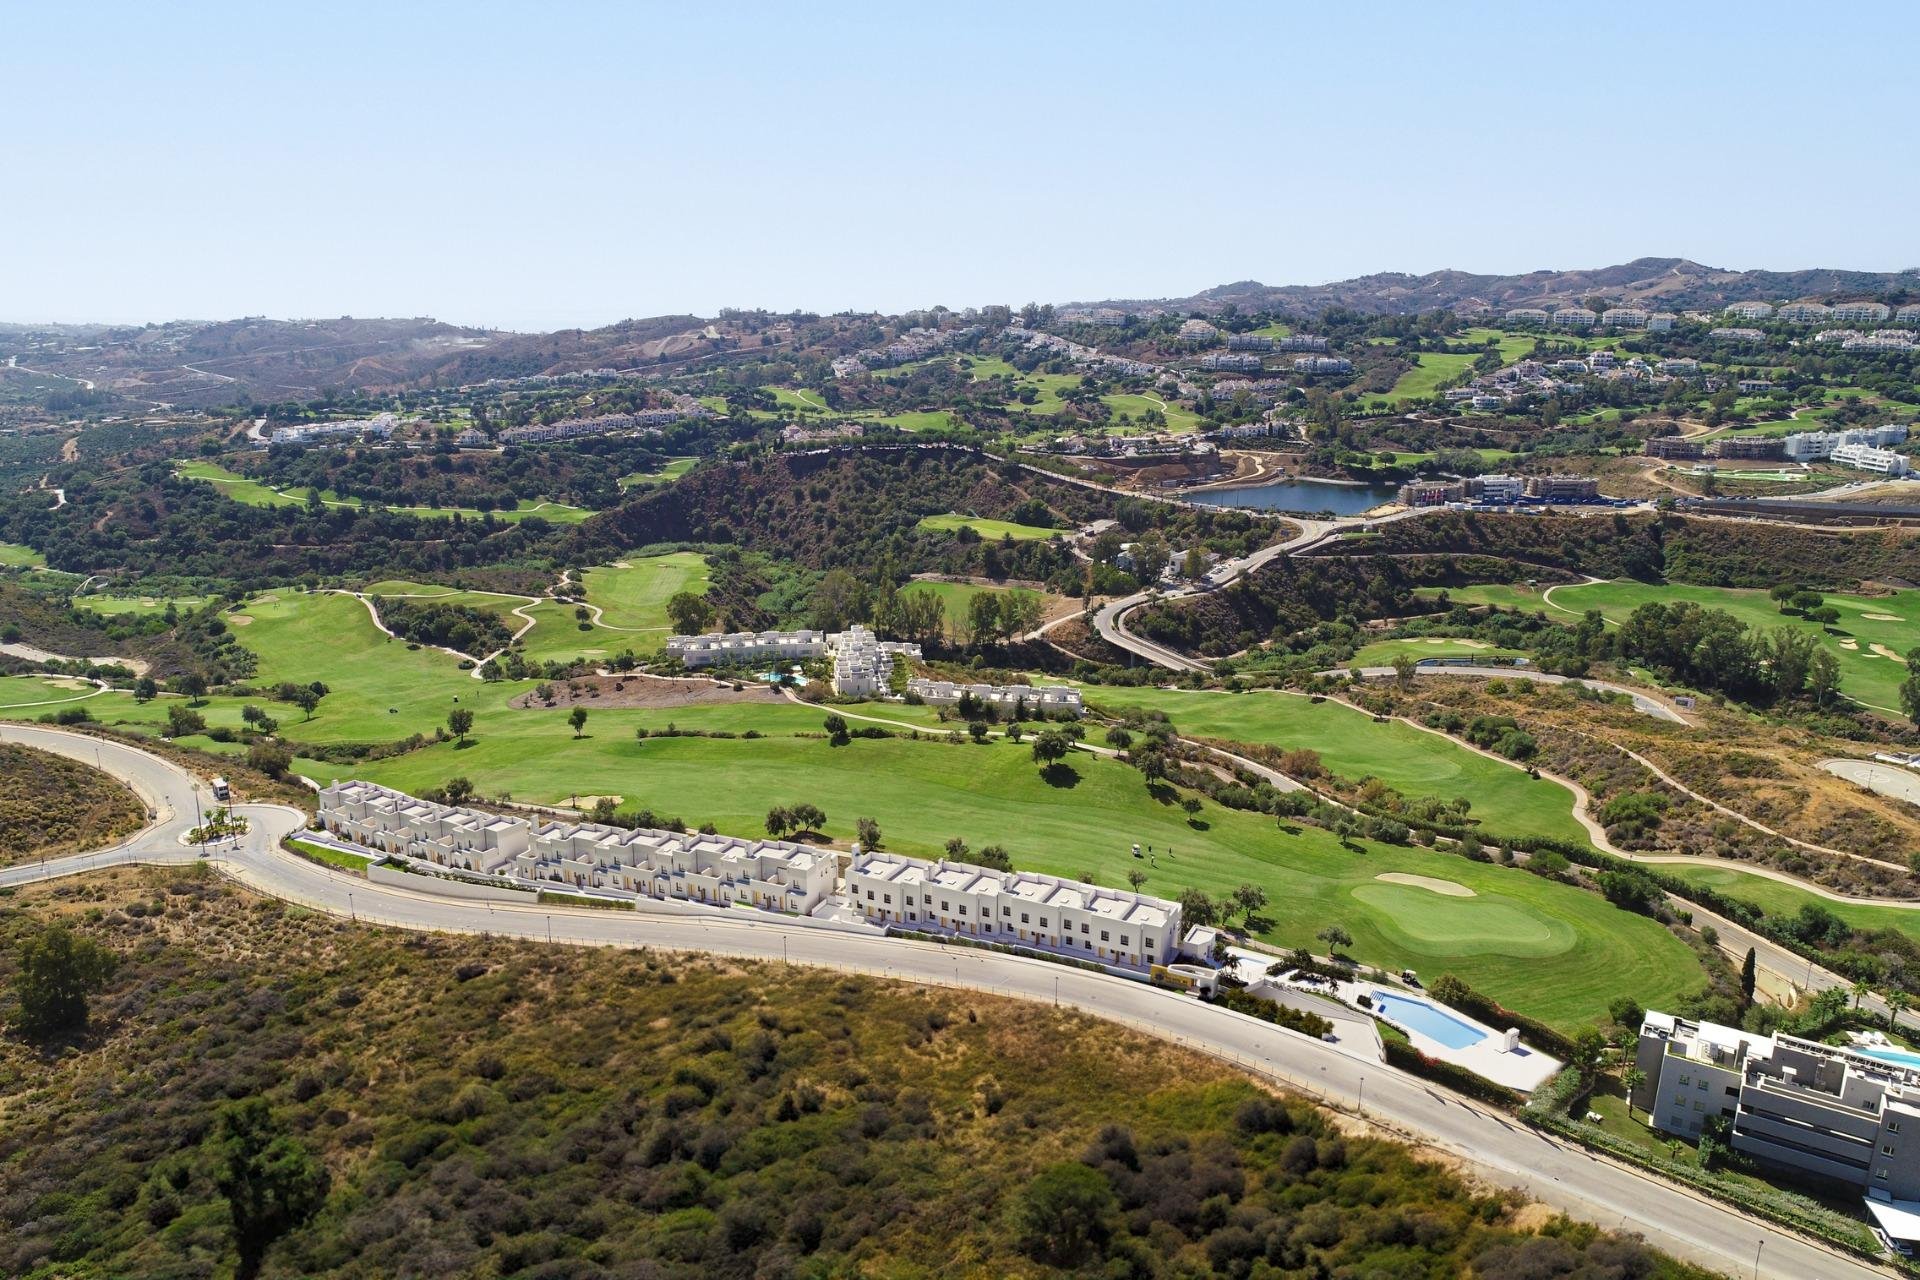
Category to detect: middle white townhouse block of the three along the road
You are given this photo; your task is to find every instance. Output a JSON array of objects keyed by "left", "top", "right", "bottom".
[{"left": 511, "top": 821, "right": 839, "bottom": 915}]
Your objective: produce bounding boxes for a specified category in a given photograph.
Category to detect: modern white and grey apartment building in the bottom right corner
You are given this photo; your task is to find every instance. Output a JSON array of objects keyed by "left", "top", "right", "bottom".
[{"left": 1632, "top": 1013, "right": 1920, "bottom": 1253}]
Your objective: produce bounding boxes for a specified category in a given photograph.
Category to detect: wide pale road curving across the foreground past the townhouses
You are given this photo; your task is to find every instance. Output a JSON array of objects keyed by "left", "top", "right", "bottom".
[{"left": 0, "top": 723, "right": 1887, "bottom": 1280}]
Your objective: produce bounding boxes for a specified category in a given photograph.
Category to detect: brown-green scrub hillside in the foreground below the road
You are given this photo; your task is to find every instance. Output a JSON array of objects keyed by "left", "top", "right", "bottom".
[{"left": 0, "top": 869, "right": 1701, "bottom": 1280}]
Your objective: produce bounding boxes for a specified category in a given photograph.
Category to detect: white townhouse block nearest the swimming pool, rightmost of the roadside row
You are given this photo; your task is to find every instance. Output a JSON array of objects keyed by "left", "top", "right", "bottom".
[{"left": 847, "top": 850, "right": 1181, "bottom": 969}]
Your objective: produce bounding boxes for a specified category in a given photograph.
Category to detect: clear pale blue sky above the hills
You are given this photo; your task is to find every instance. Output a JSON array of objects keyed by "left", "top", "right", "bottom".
[{"left": 0, "top": 0, "right": 1920, "bottom": 328}]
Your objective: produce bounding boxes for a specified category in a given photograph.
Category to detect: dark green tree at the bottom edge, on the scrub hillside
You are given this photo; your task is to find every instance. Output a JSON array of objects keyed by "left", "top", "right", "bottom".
[{"left": 209, "top": 1098, "right": 332, "bottom": 1280}]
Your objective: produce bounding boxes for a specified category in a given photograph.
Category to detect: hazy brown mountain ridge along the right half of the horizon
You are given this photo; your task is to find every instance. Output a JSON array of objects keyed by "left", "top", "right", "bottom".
[{"left": 1104, "top": 257, "right": 1920, "bottom": 315}]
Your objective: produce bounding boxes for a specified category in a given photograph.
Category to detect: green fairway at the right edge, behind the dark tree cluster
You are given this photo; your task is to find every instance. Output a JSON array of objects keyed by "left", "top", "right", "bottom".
[{"left": 1553, "top": 581, "right": 1920, "bottom": 714}]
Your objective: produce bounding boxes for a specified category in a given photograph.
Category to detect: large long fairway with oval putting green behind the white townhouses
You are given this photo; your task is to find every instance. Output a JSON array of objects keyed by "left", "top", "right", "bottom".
[{"left": 322, "top": 721, "right": 1697, "bottom": 1025}]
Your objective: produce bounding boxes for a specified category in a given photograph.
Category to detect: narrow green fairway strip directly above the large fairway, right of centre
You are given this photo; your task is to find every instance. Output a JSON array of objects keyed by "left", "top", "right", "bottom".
[{"left": 1083, "top": 685, "right": 1586, "bottom": 844}]
